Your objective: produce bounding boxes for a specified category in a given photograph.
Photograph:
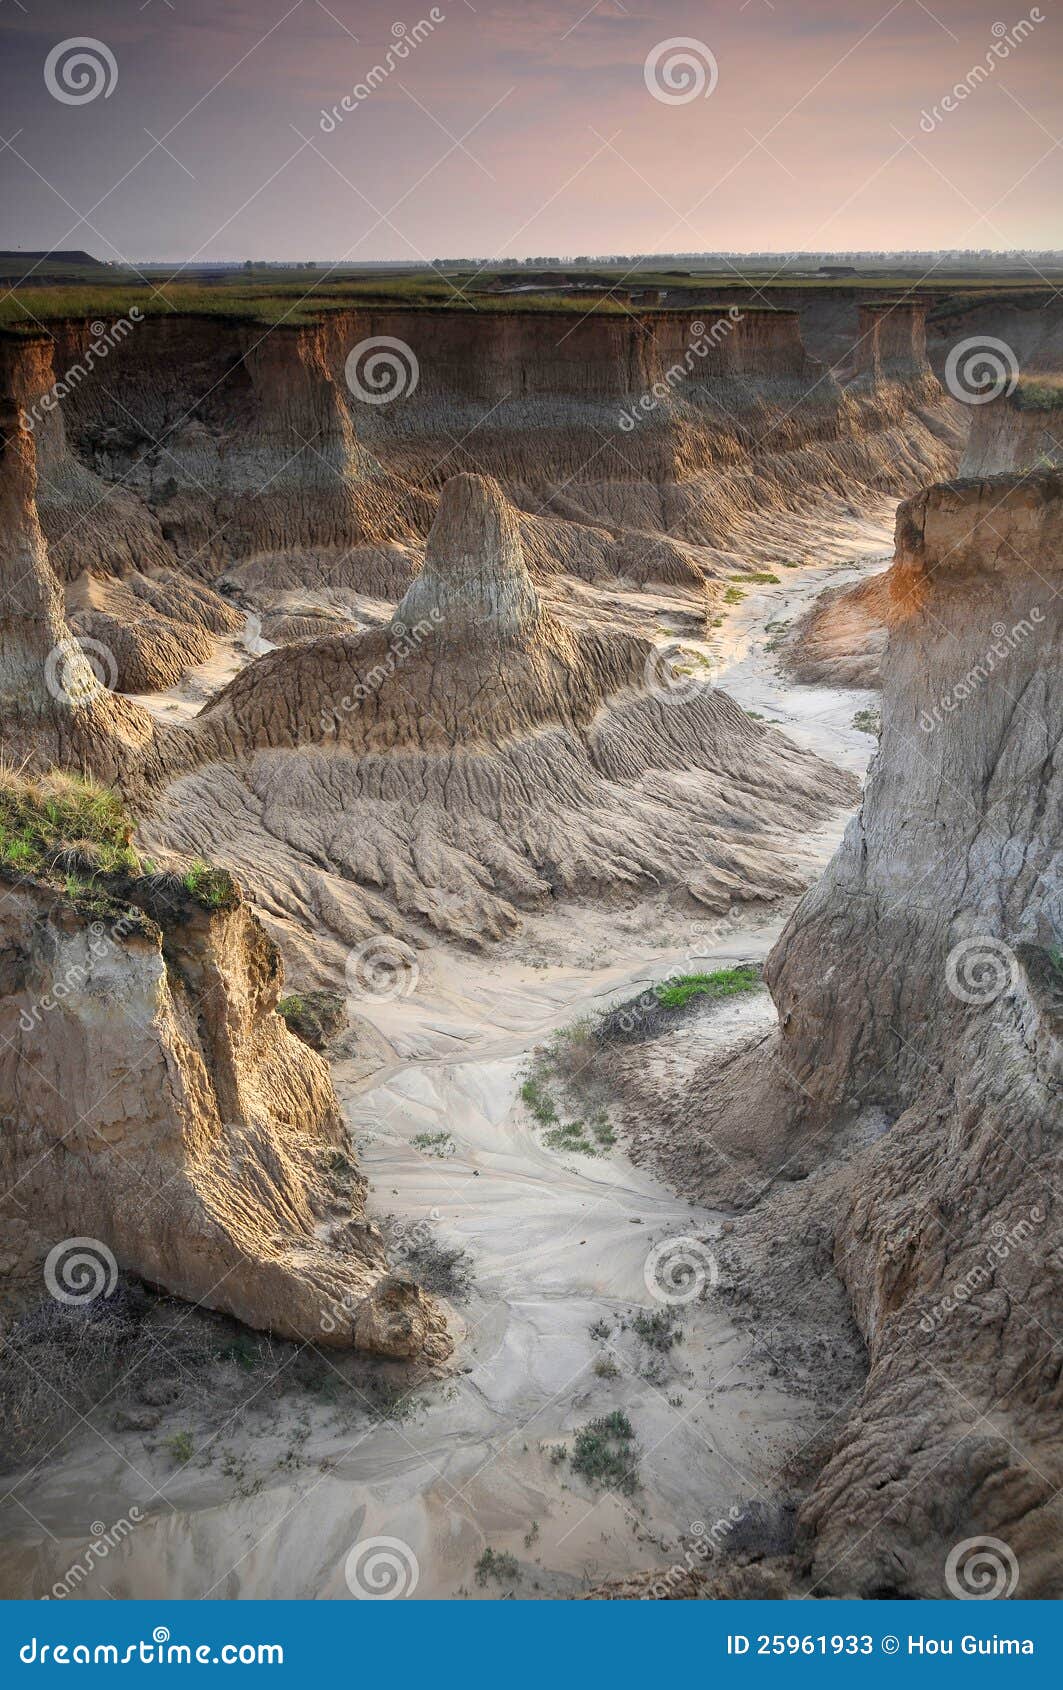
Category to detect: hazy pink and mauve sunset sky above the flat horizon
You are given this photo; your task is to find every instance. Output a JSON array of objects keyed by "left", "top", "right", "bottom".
[{"left": 0, "top": 0, "right": 1063, "bottom": 262}]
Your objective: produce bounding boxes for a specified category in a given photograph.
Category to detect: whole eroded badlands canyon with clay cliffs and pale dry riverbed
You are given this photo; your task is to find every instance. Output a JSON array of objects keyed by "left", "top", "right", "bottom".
[{"left": 0, "top": 290, "right": 1063, "bottom": 1597}]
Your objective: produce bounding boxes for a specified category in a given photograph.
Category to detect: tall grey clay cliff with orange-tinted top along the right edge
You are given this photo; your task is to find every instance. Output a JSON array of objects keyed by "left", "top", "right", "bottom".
[{"left": 615, "top": 472, "right": 1063, "bottom": 1597}]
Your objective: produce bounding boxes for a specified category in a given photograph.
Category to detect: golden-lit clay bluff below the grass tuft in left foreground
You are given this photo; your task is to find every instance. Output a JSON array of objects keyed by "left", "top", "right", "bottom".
[{"left": 0, "top": 877, "right": 448, "bottom": 1357}]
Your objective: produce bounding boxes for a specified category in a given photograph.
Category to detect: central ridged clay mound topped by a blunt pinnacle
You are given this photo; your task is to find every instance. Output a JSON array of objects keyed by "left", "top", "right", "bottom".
[{"left": 138, "top": 475, "right": 853, "bottom": 957}]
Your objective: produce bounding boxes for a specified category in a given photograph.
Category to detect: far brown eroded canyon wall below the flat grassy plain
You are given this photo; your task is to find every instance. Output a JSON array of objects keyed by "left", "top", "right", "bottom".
[{"left": 16, "top": 304, "right": 960, "bottom": 598}]
